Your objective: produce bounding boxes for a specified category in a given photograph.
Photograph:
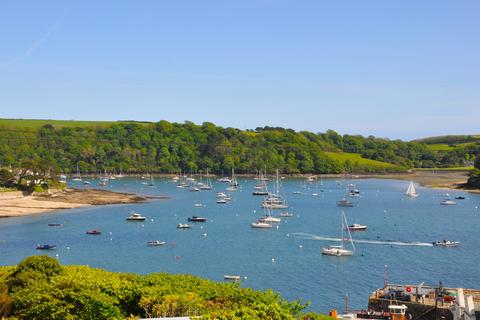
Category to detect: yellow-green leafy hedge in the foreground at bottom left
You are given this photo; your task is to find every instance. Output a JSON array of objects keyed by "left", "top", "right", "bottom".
[{"left": 0, "top": 256, "right": 327, "bottom": 320}]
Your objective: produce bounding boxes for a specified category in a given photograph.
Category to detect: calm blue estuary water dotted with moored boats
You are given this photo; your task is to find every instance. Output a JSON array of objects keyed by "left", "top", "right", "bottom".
[{"left": 0, "top": 178, "right": 480, "bottom": 312}]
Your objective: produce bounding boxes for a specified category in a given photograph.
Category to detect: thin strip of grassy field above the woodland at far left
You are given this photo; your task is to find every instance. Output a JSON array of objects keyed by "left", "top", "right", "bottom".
[{"left": 0, "top": 119, "right": 146, "bottom": 129}]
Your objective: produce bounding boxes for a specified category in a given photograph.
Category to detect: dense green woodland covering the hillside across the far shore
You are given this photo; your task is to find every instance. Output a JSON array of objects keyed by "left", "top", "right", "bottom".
[{"left": 0, "top": 121, "right": 480, "bottom": 179}]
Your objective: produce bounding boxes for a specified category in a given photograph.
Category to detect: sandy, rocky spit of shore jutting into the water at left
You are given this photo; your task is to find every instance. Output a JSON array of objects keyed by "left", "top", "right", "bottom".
[{"left": 0, "top": 188, "right": 168, "bottom": 218}]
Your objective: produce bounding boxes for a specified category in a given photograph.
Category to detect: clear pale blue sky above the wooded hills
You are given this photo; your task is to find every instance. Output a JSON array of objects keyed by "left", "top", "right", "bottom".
[{"left": 0, "top": 0, "right": 480, "bottom": 139}]
